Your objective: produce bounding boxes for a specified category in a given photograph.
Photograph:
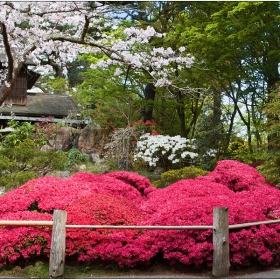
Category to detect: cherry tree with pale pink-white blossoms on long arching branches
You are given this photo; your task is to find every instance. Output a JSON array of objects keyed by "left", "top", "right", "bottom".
[{"left": 0, "top": 2, "right": 197, "bottom": 109}]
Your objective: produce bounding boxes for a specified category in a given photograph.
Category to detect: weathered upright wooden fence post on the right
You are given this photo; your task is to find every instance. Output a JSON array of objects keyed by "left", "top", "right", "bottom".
[{"left": 212, "top": 207, "right": 230, "bottom": 277}]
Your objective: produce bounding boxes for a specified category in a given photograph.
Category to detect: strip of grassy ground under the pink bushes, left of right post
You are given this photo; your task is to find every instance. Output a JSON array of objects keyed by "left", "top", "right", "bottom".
[{"left": 0, "top": 257, "right": 211, "bottom": 279}]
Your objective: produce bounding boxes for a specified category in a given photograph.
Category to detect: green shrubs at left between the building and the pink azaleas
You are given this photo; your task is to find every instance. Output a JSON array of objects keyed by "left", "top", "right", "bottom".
[{"left": 0, "top": 119, "right": 88, "bottom": 191}]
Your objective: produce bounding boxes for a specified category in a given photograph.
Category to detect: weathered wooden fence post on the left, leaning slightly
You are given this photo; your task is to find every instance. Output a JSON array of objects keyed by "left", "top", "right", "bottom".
[{"left": 49, "top": 210, "right": 67, "bottom": 277}]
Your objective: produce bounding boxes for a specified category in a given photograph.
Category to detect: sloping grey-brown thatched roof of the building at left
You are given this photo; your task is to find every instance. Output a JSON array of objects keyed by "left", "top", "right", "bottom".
[{"left": 0, "top": 93, "right": 78, "bottom": 118}]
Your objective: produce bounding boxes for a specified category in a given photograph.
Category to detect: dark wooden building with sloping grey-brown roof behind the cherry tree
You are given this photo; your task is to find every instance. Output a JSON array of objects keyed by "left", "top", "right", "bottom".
[{"left": 0, "top": 54, "right": 83, "bottom": 127}]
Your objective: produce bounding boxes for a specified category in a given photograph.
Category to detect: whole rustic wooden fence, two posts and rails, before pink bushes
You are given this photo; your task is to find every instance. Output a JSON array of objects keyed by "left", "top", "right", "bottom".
[{"left": 0, "top": 207, "right": 280, "bottom": 278}]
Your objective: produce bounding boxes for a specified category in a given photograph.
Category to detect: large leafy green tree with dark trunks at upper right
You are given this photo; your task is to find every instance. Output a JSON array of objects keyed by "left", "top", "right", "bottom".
[{"left": 173, "top": 2, "right": 279, "bottom": 153}]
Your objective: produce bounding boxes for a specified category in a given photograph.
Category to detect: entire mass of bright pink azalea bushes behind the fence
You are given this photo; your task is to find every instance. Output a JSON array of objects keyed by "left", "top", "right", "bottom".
[{"left": 0, "top": 160, "right": 280, "bottom": 267}]
